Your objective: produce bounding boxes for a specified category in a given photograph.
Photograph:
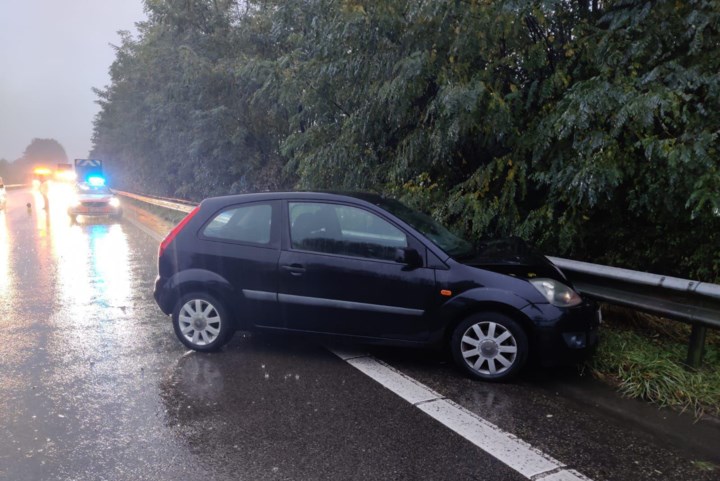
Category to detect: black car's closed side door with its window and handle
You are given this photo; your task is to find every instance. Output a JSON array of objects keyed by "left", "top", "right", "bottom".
[{"left": 278, "top": 201, "right": 439, "bottom": 341}]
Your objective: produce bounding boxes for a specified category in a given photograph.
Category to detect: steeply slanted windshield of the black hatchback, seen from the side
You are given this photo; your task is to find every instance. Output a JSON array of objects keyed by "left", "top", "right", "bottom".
[{"left": 377, "top": 199, "right": 474, "bottom": 258}]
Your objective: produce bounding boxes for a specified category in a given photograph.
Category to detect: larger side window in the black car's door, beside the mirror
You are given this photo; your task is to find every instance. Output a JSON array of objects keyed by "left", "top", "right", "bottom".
[{"left": 289, "top": 202, "right": 408, "bottom": 260}]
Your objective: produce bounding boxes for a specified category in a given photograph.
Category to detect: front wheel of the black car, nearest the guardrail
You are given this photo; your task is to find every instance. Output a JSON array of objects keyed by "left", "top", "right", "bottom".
[{"left": 450, "top": 312, "right": 528, "bottom": 381}]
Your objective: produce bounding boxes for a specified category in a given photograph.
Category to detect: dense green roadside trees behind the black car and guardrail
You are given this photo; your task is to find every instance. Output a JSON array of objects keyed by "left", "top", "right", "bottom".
[{"left": 93, "top": 0, "right": 720, "bottom": 281}]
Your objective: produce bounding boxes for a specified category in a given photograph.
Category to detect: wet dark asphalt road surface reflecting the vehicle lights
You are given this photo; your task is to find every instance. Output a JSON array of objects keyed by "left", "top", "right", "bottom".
[{"left": 0, "top": 190, "right": 720, "bottom": 481}]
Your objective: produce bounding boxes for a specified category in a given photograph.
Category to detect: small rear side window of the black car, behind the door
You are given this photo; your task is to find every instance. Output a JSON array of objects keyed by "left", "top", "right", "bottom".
[{"left": 202, "top": 204, "right": 272, "bottom": 245}]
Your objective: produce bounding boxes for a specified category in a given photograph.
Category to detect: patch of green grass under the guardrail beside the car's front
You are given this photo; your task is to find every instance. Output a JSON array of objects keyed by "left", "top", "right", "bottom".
[{"left": 588, "top": 306, "right": 720, "bottom": 418}]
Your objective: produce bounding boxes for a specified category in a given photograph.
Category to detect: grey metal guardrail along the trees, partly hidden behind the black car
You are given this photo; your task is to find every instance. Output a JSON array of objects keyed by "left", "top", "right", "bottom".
[{"left": 116, "top": 191, "right": 720, "bottom": 368}]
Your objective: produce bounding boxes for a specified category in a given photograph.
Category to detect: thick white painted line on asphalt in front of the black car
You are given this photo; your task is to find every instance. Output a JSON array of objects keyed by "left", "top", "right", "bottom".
[{"left": 330, "top": 349, "right": 591, "bottom": 481}]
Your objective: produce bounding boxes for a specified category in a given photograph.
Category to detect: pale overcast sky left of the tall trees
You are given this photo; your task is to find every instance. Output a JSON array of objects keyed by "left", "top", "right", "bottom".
[{"left": 0, "top": 0, "right": 146, "bottom": 160}]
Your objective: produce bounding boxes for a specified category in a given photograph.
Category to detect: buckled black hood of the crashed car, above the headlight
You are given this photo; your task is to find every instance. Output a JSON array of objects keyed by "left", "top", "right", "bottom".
[{"left": 458, "top": 237, "right": 568, "bottom": 283}]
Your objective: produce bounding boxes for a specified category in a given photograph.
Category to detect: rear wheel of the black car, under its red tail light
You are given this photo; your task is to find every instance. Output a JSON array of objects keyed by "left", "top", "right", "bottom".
[{"left": 172, "top": 292, "right": 233, "bottom": 352}]
